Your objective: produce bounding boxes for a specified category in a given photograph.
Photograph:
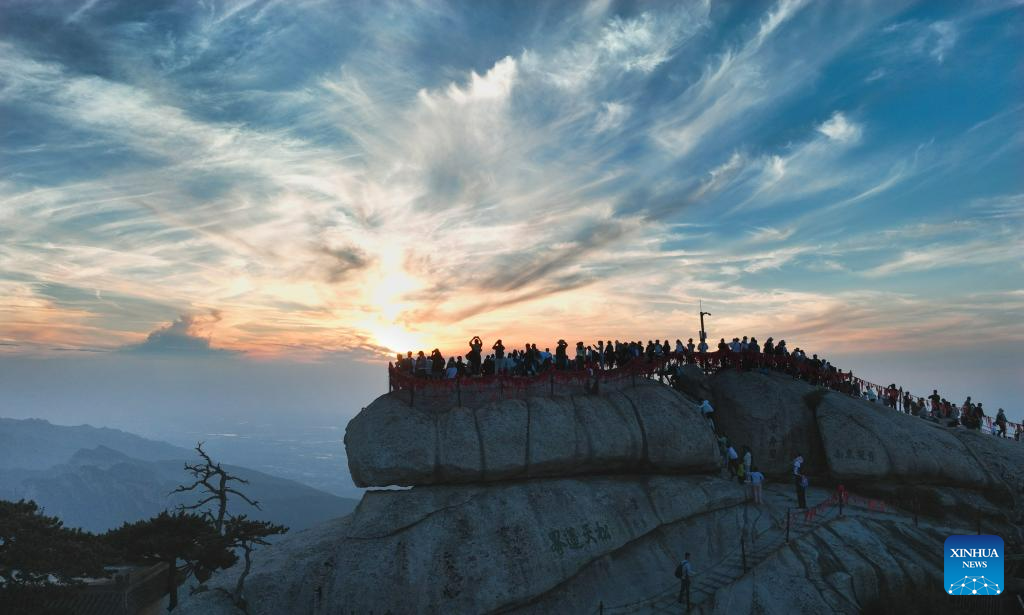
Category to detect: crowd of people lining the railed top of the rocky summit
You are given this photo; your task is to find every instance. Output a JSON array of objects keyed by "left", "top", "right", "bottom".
[{"left": 392, "top": 336, "right": 1024, "bottom": 441}]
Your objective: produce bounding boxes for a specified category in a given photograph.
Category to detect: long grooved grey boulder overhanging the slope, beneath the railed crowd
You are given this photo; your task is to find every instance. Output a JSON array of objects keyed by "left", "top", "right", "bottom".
[{"left": 345, "top": 382, "right": 719, "bottom": 487}]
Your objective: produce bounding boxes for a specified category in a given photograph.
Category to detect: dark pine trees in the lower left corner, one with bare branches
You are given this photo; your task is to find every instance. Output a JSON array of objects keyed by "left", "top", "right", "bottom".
[{"left": 0, "top": 443, "right": 288, "bottom": 615}]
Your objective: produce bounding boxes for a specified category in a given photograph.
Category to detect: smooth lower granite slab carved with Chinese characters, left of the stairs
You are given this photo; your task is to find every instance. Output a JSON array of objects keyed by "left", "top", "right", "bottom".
[{"left": 183, "top": 476, "right": 743, "bottom": 615}]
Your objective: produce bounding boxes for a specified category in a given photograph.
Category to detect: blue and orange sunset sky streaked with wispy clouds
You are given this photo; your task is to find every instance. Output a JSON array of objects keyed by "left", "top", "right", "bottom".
[{"left": 0, "top": 0, "right": 1024, "bottom": 420}]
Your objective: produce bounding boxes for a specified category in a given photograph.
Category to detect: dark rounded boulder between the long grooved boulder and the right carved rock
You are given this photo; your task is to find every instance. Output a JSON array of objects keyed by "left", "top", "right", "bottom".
[{"left": 711, "top": 369, "right": 827, "bottom": 478}]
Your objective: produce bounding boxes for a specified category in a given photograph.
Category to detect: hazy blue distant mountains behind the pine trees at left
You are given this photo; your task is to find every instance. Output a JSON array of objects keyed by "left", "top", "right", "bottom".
[{"left": 0, "top": 419, "right": 358, "bottom": 532}]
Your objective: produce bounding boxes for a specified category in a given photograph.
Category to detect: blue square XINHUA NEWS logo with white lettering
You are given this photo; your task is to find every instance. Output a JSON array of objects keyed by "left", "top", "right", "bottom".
[{"left": 943, "top": 534, "right": 1006, "bottom": 596}]
